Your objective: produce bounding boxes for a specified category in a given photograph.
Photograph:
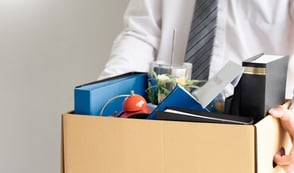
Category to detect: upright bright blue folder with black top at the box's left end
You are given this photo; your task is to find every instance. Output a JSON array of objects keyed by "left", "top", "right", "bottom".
[{"left": 74, "top": 72, "right": 148, "bottom": 116}]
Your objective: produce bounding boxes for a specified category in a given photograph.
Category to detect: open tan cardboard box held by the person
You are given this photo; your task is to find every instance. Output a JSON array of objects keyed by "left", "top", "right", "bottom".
[{"left": 62, "top": 113, "right": 290, "bottom": 173}]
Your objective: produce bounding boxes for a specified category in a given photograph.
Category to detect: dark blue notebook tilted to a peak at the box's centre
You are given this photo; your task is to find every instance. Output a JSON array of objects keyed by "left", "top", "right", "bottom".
[{"left": 147, "top": 85, "right": 209, "bottom": 119}]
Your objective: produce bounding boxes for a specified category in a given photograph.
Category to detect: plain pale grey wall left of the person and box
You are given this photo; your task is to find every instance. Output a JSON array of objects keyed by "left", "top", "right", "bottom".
[{"left": 0, "top": 0, "right": 128, "bottom": 173}]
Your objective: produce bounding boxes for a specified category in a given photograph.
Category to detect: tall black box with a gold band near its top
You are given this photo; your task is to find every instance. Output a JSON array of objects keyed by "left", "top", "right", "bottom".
[{"left": 229, "top": 54, "right": 289, "bottom": 121}]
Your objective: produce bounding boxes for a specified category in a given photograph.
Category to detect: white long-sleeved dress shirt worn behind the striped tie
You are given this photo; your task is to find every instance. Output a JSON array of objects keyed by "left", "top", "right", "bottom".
[{"left": 99, "top": 0, "right": 294, "bottom": 98}]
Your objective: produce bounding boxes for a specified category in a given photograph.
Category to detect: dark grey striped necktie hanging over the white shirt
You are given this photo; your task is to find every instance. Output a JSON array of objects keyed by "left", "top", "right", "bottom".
[{"left": 185, "top": 0, "right": 217, "bottom": 80}]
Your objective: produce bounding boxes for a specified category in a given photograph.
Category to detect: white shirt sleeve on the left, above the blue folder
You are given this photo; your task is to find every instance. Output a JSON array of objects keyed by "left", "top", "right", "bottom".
[{"left": 98, "top": 0, "right": 162, "bottom": 79}]
